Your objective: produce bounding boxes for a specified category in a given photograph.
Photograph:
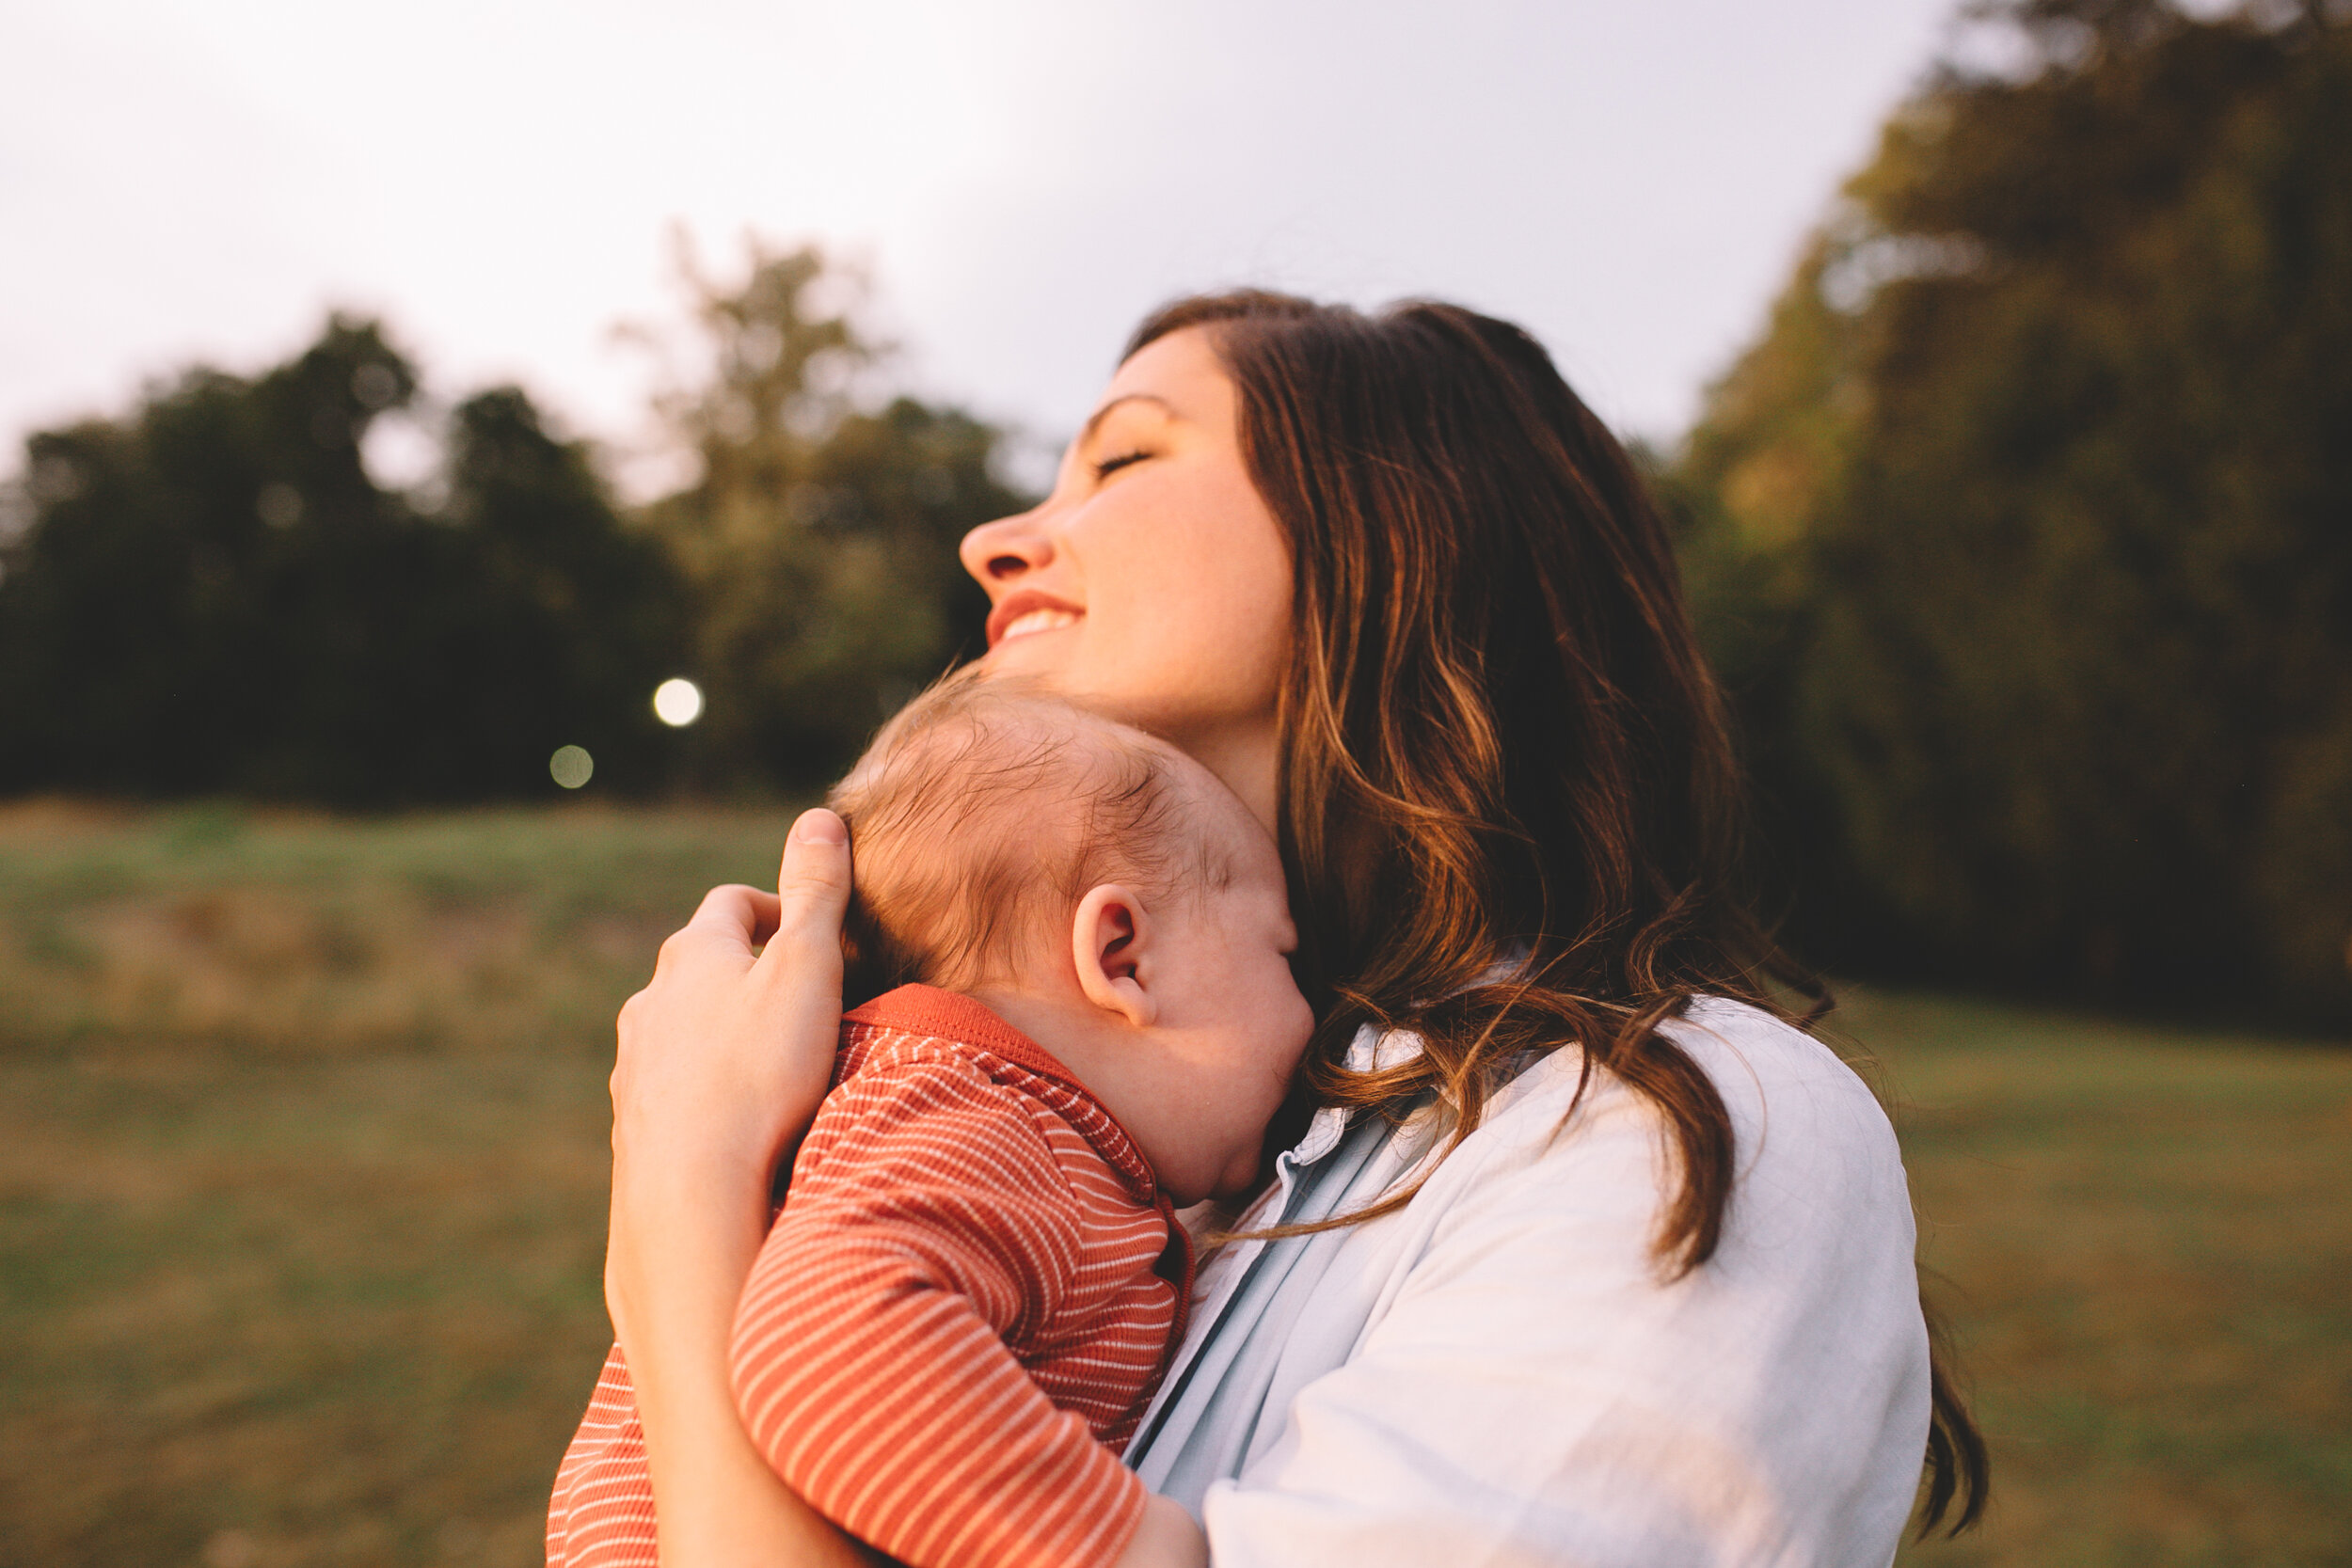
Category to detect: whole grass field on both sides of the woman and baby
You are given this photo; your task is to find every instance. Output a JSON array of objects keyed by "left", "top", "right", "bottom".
[{"left": 0, "top": 806, "right": 2352, "bottom": 1568}]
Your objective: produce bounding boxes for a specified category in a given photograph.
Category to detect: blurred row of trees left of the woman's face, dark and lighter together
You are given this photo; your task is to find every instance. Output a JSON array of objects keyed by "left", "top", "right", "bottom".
[{"left": 0, "top": 246, "right": 1025, "bottom": 806}]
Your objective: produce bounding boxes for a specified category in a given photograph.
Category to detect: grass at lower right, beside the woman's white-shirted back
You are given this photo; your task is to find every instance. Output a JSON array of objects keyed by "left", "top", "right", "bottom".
[{"left": 1853, "top": 997, "right": 2352, "bottom": 1568}]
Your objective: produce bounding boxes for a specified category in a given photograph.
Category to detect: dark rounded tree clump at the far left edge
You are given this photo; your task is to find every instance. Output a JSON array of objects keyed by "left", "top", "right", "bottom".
[{"left": 0, "top": 317, "right": 680, "bottom": 804}]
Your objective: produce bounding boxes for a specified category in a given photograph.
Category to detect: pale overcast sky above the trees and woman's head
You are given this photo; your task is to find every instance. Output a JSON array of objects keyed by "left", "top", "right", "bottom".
[{"left": 0, "top": 0, "right": 1952, "bottom": 491}]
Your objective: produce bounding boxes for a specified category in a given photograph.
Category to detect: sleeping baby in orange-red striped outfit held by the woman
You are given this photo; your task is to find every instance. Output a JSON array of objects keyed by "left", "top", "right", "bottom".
[{"left": 548, "top": 677, "right": 1312, "bottom": 1568}]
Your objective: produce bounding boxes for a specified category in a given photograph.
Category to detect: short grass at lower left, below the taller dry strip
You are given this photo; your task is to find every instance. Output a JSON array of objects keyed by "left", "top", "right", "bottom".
[{"left": 0, "top": 1046, "right": 610, "bottom": 1566}]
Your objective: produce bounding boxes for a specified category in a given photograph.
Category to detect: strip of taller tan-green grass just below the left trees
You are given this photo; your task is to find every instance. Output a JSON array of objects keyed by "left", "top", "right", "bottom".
[{"left": 0, "top": 801, "right": 788, "bottom": 1055}]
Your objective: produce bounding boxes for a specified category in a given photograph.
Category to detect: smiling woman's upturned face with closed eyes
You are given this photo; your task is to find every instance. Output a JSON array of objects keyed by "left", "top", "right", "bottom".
[{"left": 962, "top": 329, "right": 1292, "bottom": 820}]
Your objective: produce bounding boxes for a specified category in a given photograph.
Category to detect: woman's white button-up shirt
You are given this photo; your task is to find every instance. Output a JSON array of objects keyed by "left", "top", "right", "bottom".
[{"left": 1127, "top": 999, "right": 1929, "bottom": 1568}]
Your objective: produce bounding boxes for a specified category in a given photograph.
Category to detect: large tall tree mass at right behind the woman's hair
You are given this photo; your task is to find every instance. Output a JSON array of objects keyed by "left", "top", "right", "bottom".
[{"left": 1665, "top": 0, "right": 2352, "bottom": 1021}]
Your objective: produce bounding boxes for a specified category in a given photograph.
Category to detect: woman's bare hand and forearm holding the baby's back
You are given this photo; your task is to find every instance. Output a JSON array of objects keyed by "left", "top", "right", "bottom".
[{"left": 605, "top": 811, "right": 864, "bottom": 1568}]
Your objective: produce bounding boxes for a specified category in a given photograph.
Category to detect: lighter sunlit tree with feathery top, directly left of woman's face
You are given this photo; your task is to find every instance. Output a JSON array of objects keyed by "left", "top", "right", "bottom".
[{"left": 649, "top": 245, "right": 1028, "bottom": 787}]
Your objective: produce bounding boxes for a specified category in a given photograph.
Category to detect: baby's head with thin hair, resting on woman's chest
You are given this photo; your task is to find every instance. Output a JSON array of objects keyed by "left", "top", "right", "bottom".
[{"left": 831, "top": 673, "right": 1315, "bottom": 1201}]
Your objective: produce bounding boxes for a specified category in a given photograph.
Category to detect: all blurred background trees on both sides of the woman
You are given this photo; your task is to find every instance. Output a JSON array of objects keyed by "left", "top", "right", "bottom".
[{"left": 0, "top": 0, "right": 2352, "bottom": 1021}]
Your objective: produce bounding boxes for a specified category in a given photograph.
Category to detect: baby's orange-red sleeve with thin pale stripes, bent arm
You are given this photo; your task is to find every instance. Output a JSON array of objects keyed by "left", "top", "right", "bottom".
[{"left": 734, "top": 1060, "right": 1146, "bottom": 1568}]
